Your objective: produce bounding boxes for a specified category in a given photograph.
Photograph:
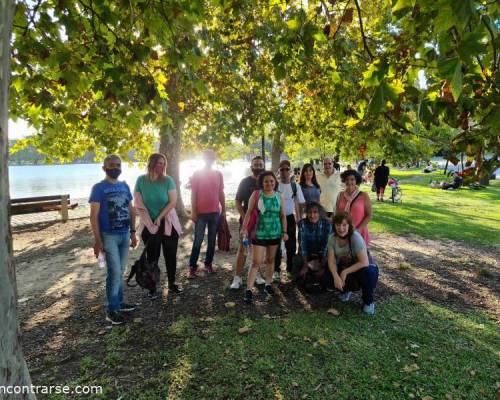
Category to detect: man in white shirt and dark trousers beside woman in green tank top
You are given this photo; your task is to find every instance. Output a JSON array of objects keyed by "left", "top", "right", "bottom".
[{"left": 273, "top": 160, "right": 306, "bottom": 281}]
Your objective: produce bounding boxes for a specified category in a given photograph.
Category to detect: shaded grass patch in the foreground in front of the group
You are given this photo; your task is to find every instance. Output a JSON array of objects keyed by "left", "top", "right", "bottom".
[{"left": 45, "top": 296, "right": 500, "bottom": 400}]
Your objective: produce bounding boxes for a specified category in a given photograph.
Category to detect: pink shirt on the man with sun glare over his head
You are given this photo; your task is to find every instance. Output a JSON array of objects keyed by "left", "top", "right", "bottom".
[{"left": 191, "top": 169, "right": 224, "bottom": 214}]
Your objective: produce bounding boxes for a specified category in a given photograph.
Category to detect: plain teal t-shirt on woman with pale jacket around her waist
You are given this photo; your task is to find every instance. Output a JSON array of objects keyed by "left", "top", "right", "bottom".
[{"left": 134, "top": 175, "right": 176, "bottom": 221}]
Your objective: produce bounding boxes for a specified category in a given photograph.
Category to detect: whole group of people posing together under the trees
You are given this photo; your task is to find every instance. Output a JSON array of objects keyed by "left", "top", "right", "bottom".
[{"left": 89, "top": 150, "right": 378, "bottom": 324}]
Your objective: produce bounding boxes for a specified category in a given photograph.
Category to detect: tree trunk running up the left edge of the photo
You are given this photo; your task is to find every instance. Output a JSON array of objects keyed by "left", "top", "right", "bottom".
[{"left": 0, "top": 0, "right": 35, "bottom": 399}]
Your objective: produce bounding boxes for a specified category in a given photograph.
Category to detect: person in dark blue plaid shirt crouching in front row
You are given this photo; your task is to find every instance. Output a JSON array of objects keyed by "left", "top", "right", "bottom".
[{"left": 293, "top": 202, "right": 332, "bottom": 290}]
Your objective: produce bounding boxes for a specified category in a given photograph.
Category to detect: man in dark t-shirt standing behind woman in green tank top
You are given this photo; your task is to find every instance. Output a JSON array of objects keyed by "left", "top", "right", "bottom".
[{"left": 230, "top": 156, "right": 266, "bottom": 289}]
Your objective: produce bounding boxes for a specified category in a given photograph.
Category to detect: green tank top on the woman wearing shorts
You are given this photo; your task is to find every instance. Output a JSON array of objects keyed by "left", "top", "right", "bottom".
[{"left": 255, "top": 192, "right": 281, "bottom": 240}]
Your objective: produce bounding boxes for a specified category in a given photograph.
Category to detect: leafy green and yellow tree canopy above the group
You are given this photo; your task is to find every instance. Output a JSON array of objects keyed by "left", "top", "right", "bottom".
[{"left": 11, "top": 0, "right": 500, "bottom": 178}]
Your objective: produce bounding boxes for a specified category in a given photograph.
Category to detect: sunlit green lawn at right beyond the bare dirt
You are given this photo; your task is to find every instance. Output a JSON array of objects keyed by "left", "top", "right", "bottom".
[{"left": 364, "top": 169, "right": 500, "bottom": 247}]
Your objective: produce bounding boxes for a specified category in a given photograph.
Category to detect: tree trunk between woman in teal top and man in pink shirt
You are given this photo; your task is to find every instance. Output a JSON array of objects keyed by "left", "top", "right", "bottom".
[{"left": 160, "top": 118, "right": 187, "bottom": 217}]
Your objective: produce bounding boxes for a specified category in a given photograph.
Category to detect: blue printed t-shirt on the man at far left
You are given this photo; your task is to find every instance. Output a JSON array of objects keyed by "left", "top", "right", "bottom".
[{"left": 89, "top": 180, "right": 132, "bottom": 233}]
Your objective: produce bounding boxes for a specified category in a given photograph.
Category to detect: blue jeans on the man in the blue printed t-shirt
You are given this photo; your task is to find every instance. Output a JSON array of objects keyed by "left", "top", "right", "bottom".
[{"left": 101, "top": 232, "right": 130, "bottom": 312}]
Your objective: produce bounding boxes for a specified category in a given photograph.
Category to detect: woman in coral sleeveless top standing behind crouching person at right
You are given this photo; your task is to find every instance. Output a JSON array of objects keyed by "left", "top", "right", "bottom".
[{"left": 335, "top": 170, "right": 372, "bottom": 246}]
